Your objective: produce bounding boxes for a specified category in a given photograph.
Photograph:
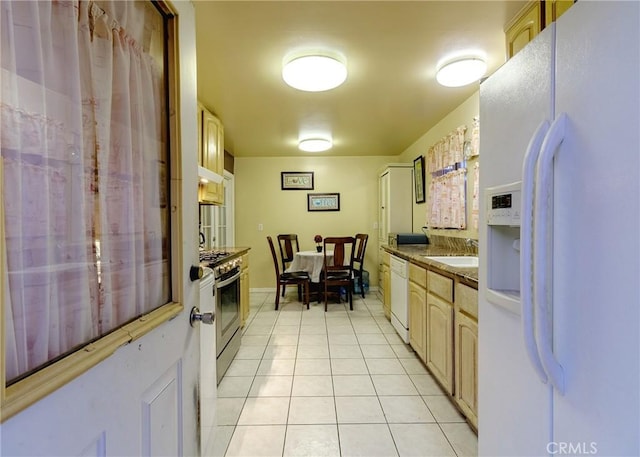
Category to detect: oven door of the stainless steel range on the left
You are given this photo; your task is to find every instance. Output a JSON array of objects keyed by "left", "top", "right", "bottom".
[{"left": 215, "top": 268, "right": 240, "bottom": 358}]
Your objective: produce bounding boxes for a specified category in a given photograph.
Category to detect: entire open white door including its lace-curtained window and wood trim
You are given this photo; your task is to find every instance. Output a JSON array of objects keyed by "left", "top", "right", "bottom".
[{"left": 0, "top": 1, "right": 200, "bottom": 455}]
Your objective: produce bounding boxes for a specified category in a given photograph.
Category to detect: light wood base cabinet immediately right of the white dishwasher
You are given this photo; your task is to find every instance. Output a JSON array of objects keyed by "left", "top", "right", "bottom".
[{"left": 409, "top": 263, "right": 427, "bottom": 362}]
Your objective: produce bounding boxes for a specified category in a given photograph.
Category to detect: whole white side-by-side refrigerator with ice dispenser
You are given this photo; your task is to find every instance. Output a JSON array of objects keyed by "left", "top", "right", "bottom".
[{"left": 478, "top": 0, "right": 640, "bottom": 456}]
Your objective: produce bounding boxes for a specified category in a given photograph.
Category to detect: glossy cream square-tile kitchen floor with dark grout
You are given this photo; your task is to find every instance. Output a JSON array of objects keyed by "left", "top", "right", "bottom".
[{"left": 205, "top": 291, "right": 477, "bottom": 457}]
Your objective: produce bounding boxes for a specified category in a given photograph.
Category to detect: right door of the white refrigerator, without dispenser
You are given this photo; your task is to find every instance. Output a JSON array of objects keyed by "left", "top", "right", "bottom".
[{"left": 552, "top": 1, "right": 640, "bottom": 455}]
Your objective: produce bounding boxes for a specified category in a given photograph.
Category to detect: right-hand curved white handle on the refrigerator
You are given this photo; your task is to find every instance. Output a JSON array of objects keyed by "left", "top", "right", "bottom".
[{"left": 533, "top": 113, "right": 566, "bottom": 395}]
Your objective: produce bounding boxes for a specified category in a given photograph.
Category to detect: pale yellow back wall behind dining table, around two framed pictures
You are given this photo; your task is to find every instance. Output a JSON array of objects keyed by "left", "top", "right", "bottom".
[{"left": 235, "top": 156, "right": 390, "bottom": 289}]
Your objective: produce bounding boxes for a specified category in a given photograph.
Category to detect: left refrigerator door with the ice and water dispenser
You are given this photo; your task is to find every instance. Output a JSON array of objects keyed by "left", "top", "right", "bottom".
[{"left": 478, "top": 25, "right": 554, "bottom": 456}]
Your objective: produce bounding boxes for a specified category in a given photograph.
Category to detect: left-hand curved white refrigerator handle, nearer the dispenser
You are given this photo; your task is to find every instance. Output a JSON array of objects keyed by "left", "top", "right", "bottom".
[{"left": 520, "top": 119, "right": 549, "bottom": 384}]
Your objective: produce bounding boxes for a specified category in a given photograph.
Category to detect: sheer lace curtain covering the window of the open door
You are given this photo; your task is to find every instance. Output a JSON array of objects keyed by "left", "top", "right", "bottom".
[{"left": 0, "top": 1, "right": 170, "bottom": 380}]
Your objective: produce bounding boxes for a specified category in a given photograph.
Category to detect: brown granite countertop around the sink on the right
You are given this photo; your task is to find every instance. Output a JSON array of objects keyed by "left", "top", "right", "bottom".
[{"left": 382, "top": 244, "right": 478, "bottom": 288}]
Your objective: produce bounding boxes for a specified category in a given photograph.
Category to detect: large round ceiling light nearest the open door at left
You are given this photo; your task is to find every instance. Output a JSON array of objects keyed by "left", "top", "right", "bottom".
[{"left": 282, "top": 55, "right": 347, "bottom": 92}]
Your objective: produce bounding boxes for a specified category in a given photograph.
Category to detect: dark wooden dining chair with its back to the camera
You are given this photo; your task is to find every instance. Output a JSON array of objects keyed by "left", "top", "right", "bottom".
[{"left": 321, "top": 236, "right": 355, "bottom": 311}]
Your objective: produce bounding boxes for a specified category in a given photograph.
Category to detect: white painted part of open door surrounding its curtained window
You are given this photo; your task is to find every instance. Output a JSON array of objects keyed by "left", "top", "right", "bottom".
[{"left": 0, "top": 2, "right": 200, "bottom": 456}]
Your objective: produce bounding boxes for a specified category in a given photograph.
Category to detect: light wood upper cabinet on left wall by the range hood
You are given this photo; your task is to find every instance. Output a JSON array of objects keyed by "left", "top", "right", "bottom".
[{"left": 198, "top": 104, "right": 224, "bottom": 205}]
